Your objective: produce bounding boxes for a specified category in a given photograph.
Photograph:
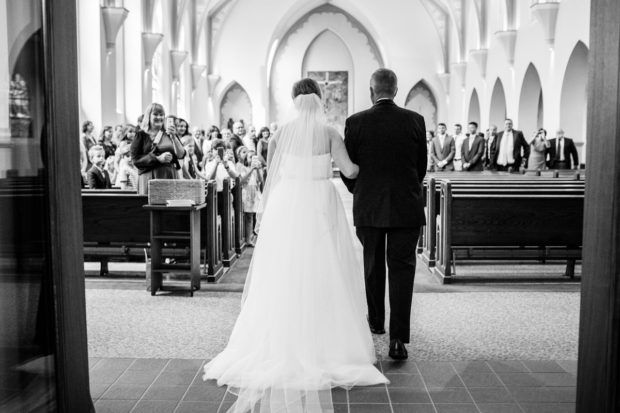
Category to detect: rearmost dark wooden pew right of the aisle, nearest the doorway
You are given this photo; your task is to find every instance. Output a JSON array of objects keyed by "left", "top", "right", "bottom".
[{"left": 434, "top": 180, "right": 584, "bottom": 283}]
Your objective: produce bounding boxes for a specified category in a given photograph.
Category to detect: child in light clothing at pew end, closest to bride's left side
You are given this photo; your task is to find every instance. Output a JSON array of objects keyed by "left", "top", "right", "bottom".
[{"left": 236, "top": 146, "right": 263, "bottom": 247}]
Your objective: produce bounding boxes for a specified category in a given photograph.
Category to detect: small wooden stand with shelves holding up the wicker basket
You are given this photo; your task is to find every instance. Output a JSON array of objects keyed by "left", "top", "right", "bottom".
[{"left": 144, "top": 203, "right": 207, "bottom": 297}]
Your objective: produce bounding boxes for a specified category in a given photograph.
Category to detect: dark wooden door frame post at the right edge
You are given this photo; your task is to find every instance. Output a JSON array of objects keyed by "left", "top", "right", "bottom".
[{"left": 577, "top": 0, "right": 620, "bottom": 413}]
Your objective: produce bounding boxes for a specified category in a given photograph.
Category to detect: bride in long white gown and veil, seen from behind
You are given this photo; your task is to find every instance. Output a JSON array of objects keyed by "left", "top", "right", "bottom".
[{"left": 203, "top": 79, "right": 388, "bottom": 413}]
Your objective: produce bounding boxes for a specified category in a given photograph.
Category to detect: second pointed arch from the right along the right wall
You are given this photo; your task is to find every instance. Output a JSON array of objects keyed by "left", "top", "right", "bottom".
[{"left": 515, "top": 63, "right": 544, "bottom": 136}]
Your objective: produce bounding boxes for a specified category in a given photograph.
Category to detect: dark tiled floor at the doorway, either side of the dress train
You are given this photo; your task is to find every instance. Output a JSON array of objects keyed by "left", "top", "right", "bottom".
[{"left": 90, "top": 358, "right": 577, "bottom": 413}]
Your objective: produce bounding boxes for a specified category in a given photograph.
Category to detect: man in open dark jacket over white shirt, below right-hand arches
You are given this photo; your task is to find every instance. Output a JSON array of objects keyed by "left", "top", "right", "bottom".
[{"left": 491, "top": 119, "right": 530, "bottom": 172}]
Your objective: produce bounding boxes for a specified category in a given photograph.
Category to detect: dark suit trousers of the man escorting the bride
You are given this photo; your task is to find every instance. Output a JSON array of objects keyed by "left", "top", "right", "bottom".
[{"left": 356, "top": 227, "right": 420, "bottom": 343}]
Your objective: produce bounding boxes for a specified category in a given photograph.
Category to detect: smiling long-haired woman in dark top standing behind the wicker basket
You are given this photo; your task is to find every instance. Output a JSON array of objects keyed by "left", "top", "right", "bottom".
[{"left": 131, "top": 103, "right": 185, "bottom": 194}]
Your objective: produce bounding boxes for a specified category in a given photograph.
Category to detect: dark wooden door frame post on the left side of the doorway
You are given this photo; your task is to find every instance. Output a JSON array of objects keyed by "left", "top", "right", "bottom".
[{"left": 41, "top": 0, "right": 92, "bottom": 412}]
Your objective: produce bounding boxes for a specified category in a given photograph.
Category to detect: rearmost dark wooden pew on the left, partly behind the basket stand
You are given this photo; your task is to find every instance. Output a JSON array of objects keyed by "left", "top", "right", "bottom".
[{"left": 82, "top": 182, "right": 223, "bottom": 281}]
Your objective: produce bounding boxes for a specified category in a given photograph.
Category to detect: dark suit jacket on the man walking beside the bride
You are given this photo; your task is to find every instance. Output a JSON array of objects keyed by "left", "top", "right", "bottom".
[{"left": 342, "top": 100, "right": 427, "bottom": 228}]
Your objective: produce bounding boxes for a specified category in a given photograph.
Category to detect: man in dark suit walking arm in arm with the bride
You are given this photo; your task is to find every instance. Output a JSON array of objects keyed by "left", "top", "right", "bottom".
[{"left": 342, "top": 69, "right": 427, "bottom": 360}]
